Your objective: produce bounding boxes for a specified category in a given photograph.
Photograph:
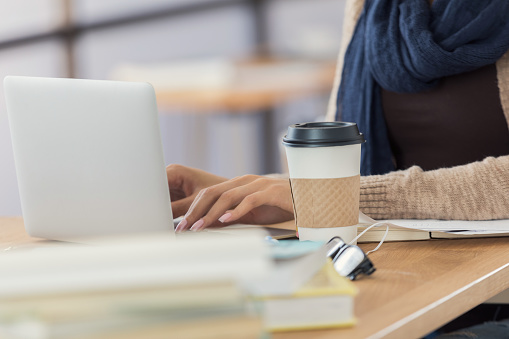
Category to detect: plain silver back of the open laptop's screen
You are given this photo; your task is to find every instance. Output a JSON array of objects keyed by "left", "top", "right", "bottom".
[{"left": 4, "top": 76, "right": 173, "bottom": 240}]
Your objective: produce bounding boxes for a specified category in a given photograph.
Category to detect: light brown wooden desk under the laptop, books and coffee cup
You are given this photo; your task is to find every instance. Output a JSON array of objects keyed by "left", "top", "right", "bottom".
[{"left": 0, "top": 218, "right": 509, "bottom": 339}]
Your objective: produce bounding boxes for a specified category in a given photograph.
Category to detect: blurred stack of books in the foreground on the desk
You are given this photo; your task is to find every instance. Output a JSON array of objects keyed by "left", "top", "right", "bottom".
[{"left": 0, "top": 230, "right": 366, "bottom": 339}]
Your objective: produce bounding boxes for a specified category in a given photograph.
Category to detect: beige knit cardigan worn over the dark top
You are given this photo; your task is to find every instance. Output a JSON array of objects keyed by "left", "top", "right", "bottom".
[{"left": 327, "top": 0, "right": 509, "bottom": 220}]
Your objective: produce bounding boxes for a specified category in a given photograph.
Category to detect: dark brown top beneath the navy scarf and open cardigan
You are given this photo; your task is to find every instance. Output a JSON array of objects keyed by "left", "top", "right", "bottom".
[{"left": 382, "top": 65, "right": 509, "bottom": 170}]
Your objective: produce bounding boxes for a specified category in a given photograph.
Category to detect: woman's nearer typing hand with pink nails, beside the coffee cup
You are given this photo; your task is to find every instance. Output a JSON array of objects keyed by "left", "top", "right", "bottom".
[{"left": 172, "top": 172, "right": 293, "bottom": 232}]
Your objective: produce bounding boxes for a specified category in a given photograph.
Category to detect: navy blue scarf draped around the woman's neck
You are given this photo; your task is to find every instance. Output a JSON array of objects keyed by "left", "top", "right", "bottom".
[{"left": 336, "top": 0, "right": 509, "bottom": 175}]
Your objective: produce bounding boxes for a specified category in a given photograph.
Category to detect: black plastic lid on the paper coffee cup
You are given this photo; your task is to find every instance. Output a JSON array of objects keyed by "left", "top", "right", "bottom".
[{"left": 283, "top": 121, "right": 365, "bottom": 147}]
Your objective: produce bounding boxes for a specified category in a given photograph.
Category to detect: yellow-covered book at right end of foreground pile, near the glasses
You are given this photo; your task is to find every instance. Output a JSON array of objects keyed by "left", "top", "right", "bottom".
[{"left": 254, "top": 260, "right": 357, "bottom": 332}]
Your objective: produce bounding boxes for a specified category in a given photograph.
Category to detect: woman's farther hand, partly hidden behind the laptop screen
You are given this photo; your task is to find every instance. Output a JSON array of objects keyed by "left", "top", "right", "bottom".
[{"left": 166, "top": 165, "right": 228, "bottom": 218}]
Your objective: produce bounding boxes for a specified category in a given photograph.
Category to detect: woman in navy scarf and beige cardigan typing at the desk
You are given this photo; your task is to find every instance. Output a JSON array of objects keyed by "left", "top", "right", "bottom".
[{"left": 167, "top": 0, "right": 509, "bottom": 231}]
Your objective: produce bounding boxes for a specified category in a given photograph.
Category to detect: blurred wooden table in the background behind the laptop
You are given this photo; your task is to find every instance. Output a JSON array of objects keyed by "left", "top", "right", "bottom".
[{"left": 114, "top": 59, "right": 336, "bottom": 173}]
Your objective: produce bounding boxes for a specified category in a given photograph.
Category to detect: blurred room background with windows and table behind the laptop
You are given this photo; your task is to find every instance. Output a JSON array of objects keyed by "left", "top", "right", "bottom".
[{"left": 0, "top": 0, "right": 345, "bottom": 215}]
